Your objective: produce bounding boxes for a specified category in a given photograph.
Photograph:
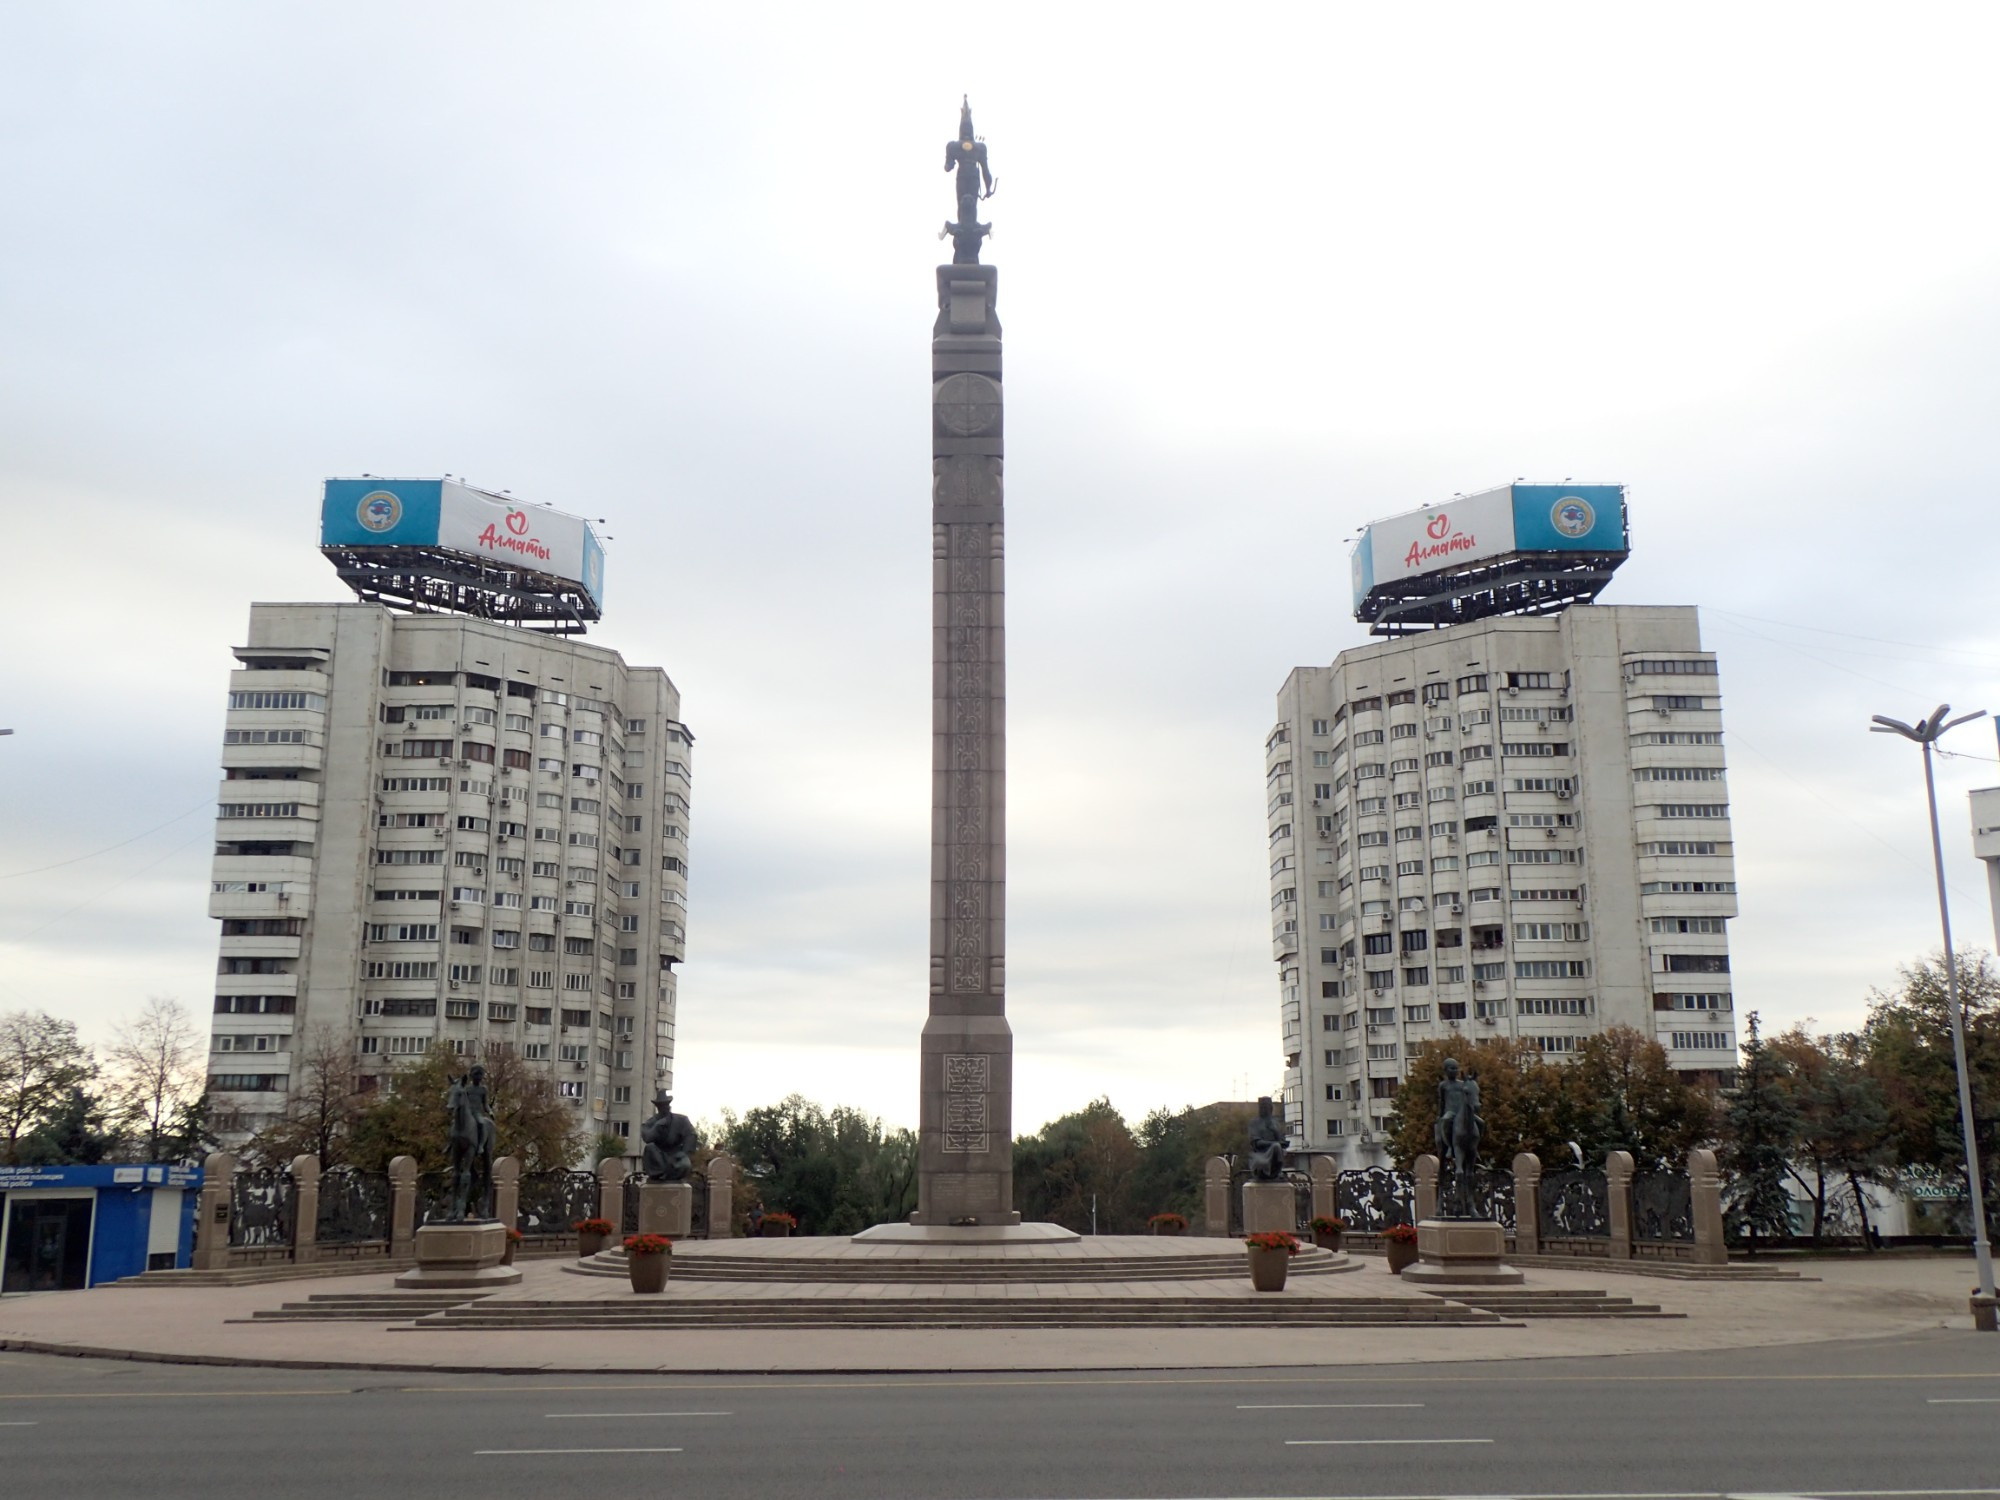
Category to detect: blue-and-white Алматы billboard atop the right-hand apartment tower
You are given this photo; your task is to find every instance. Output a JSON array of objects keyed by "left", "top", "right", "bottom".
[{"left": 1352, "top": 484, "right": 1628, "bottom": 614}]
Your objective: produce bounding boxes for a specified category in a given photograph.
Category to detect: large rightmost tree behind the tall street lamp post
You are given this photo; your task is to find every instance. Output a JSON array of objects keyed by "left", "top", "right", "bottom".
[{"left": 1862, "top": 952, "right": 2000, "bottom": 1232}]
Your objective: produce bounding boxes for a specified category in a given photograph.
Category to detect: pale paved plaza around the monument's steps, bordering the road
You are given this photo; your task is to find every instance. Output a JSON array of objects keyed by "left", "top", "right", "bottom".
[{"left": 0, "top": 1240, "right": 1976, "bottom": 1372}]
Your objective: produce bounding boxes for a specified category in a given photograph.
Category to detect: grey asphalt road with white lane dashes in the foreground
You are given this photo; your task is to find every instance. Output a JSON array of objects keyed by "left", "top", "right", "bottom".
[{"left": 0, "top": 1332, "right": 2000, "bottom": 1500}]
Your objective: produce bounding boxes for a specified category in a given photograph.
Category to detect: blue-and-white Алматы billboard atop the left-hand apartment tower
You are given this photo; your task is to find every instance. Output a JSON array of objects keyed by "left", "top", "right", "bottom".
[{"left": 320, "top": 478, "right": 604, "bottom": 610}]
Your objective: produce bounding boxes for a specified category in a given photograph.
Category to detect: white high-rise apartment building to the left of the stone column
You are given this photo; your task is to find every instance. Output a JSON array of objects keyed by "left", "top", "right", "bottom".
[{"left": 208, "top": 604, "right": 694, "bottom": 1138}]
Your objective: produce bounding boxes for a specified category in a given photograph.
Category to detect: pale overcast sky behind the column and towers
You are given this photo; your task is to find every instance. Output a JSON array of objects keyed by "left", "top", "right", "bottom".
[{"left": 0, "top": 0, "right": 2000, "bottom": 1128}]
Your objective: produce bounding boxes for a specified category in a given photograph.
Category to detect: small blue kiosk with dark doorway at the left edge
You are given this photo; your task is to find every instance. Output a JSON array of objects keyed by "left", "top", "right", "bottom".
[{"left": 0, "top": 1162, "right": 202, "bottom": 1292}]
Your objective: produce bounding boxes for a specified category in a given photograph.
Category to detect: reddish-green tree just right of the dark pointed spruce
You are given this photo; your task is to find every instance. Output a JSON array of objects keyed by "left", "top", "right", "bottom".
[{"left": 1766, "top": 1026, "right": 1894, "bottom": 1248}]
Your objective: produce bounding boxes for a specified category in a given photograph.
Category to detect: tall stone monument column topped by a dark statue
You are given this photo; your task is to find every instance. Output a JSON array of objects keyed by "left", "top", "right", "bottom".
[{"left": 866, "top": 106, "right": 1076, "bottom": 1242}]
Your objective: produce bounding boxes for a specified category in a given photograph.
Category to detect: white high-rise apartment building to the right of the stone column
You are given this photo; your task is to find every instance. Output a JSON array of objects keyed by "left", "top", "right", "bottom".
[{"left": 1264, "top": 604, "right": 1736, "bottom": 1166}]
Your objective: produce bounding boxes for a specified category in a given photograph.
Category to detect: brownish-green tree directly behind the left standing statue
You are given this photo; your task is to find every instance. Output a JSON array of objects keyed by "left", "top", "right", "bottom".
[{"left": 348, "top": 1042, "right": 584, "bottom": 1172}]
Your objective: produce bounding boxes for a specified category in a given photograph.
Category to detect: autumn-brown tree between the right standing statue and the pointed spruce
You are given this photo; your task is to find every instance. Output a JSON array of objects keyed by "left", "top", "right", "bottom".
[{"left": 1562, "top": 1026, "right": 1716, "bottom": 1172}]
